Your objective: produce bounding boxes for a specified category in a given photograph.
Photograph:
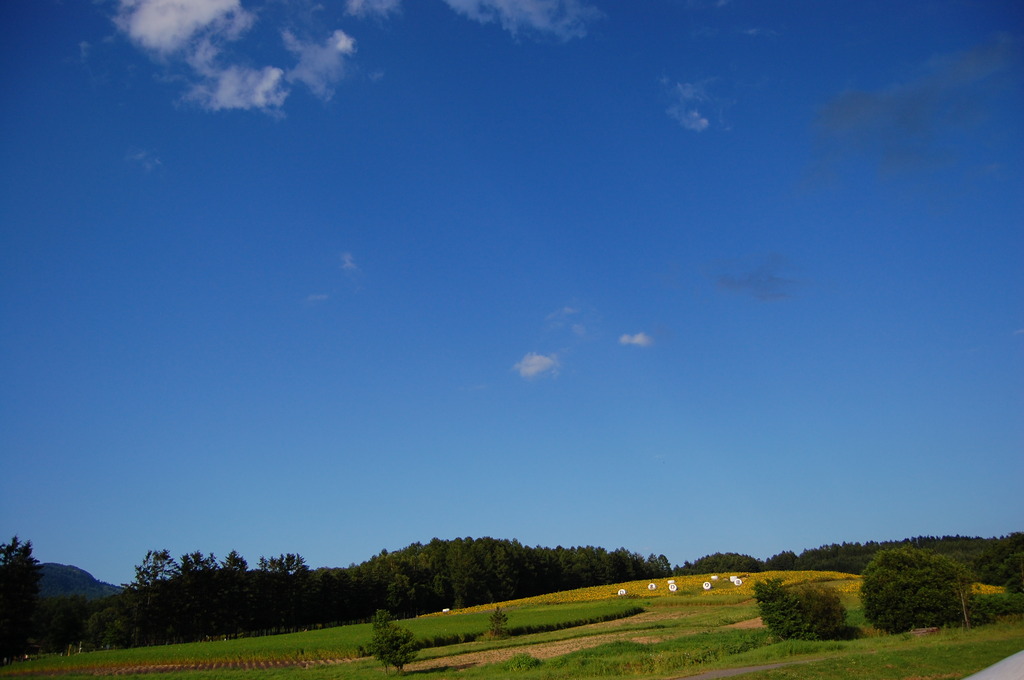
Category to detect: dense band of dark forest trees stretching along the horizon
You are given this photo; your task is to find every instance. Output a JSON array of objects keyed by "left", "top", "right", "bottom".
[{"left": 9, "top": 533, "right": 1024, "bottom": 651}]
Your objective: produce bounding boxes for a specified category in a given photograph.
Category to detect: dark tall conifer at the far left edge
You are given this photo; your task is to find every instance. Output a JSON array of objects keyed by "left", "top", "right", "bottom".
[{"left": 0, "top": 536, "right": 41, "bottom": 663}]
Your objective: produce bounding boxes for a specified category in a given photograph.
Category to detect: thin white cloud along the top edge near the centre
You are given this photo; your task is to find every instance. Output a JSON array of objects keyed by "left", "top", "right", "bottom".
[{"left": 444, "top": 0, "right": 602, "bottom": 40}]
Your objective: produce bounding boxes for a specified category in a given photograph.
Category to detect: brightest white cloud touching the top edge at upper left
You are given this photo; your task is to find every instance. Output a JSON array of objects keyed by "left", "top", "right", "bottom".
[{"left": 114, "top": 0, "right": 254, "bottom": 55}]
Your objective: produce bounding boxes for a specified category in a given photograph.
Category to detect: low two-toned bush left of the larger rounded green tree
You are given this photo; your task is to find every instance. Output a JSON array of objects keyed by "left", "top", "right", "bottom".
[{"left": 754, "top": 579, "right": 849, "bottom": 640}]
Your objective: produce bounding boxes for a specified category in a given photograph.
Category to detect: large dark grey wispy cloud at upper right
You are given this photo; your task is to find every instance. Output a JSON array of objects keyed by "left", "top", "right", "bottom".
[{"left": 817, "top": 36, "right": 1020, "bottom": 175}]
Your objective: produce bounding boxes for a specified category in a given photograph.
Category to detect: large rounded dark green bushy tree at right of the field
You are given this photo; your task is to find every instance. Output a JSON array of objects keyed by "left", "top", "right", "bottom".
[{"left": 860, "top": 546, "right": 972, "bottom": 633}]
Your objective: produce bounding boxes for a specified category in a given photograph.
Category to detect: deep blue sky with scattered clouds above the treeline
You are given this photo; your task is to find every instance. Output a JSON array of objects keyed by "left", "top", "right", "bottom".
[{"left": 0, "top": 0, "right": 1024, "bottom": 583}]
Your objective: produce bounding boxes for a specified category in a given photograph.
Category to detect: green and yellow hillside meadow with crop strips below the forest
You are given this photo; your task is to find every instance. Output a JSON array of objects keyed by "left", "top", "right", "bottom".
[{"left": 0, "top": 571, "right": 1024, "bottom": 680}]
